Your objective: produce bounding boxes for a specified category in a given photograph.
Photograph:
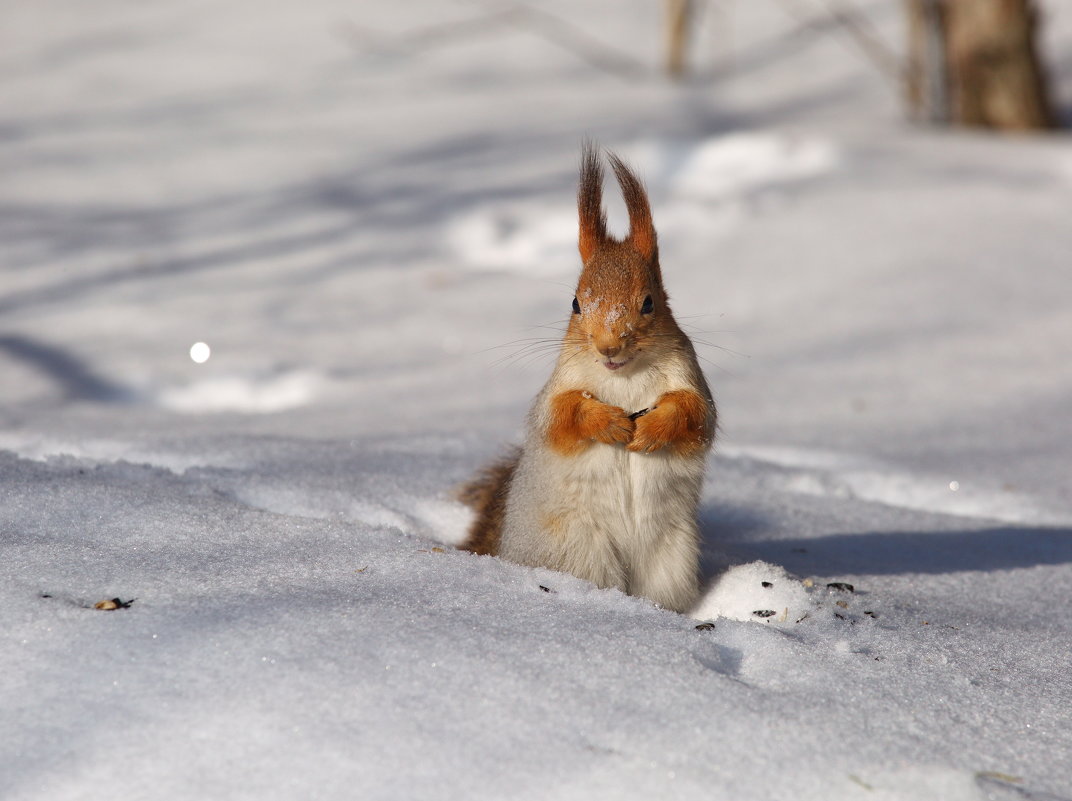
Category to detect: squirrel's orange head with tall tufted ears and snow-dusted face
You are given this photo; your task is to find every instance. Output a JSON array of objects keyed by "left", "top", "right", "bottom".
[{"left": 567, "top": 143, "right": 673, "bottom": 372}]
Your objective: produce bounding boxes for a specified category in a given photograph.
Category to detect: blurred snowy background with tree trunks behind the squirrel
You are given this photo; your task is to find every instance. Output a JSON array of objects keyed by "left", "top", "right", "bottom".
[{"left": 0, "top": 0, "right": 1072, "bottom": 521}]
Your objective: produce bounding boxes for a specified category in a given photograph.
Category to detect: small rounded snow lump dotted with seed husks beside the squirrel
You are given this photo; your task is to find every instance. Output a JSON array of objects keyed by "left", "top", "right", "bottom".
[{"left": 693, "top": 562, "right": 816, "bottom": 623}]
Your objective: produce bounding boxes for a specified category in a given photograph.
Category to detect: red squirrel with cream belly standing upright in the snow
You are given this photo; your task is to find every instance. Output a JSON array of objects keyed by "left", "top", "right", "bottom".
[{"left": 461, "top": 142, "right": 717, "bottom": 612}]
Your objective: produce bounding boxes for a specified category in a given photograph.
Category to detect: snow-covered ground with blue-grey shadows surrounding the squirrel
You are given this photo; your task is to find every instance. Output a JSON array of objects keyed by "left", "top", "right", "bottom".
[{"left": 0, "top": 0, "right": 1072, "bottom": 801}]
